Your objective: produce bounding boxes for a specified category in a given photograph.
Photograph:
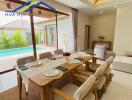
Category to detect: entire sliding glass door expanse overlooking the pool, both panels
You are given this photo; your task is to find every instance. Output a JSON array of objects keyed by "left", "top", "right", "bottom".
[{"left": 0, "top": 0, "right": 70, "bottom": 72}]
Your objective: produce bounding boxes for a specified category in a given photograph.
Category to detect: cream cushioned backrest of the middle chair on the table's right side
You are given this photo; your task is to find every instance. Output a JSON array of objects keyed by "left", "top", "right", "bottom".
[{"left": 94, "top": 61, "right": 107, "bottom": 77}]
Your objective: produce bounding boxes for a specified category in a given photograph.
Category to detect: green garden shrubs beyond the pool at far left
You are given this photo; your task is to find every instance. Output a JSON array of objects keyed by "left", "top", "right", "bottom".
[{"left": 0, "top": 29, "right": 29, "bottom": 50}]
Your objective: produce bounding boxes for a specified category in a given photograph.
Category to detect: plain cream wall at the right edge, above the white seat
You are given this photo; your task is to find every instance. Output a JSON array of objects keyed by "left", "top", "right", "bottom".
[{"left": 114, "top": 3, "right": 132, "bottom": 55}]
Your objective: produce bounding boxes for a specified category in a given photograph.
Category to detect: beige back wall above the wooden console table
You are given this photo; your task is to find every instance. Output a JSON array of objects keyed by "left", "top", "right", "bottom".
[{"left": 90, "top": 11, "right": 116, "bottom": 48}]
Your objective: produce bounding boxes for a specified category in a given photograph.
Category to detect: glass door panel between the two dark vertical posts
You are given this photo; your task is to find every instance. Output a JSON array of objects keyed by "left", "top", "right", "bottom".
[{"left": 33, "top": 8, "right": 57, "bottom": 57}]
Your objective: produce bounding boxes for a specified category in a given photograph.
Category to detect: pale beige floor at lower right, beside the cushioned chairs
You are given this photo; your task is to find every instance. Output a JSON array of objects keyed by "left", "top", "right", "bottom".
[{"left": 102, "top": 70, "right": 132, "bottom": 100}]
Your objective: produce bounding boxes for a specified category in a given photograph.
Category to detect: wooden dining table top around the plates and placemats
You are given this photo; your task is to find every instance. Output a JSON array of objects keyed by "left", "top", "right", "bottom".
[{"left": 17, "top": 54, "right": 94, "bottom": 87}]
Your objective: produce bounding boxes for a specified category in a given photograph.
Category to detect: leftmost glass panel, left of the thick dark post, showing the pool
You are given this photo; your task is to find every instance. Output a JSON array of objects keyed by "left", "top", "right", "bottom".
[{"left": 0, "top": 11, "right": 33, "bottom": 71}]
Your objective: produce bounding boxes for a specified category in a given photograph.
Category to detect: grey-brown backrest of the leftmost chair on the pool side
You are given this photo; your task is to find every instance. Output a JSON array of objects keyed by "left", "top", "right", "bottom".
[{"left": 17, "top": 56, "right": 36, "bottom": 66}]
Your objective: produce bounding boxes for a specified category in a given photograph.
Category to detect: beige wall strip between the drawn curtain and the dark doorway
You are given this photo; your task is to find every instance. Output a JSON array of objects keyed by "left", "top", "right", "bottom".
[{"left": 77, "top": 11, "right": 90, "bottom": 50}]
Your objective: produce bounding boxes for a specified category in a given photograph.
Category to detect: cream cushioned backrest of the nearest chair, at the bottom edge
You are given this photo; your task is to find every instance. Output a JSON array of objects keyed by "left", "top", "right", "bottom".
[{"left": 73, "top": 75, "right": 96, "bottom": 100}]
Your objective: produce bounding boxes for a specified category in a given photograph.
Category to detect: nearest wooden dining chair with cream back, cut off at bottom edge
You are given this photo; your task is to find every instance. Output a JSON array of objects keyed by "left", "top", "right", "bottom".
[{"left": 52, "top": 75, "right": 97, "bottom": 100}]
